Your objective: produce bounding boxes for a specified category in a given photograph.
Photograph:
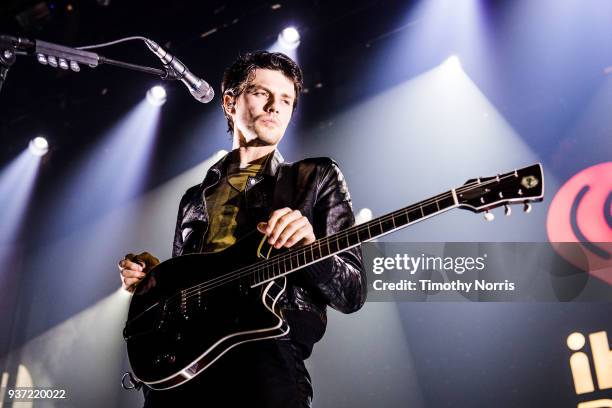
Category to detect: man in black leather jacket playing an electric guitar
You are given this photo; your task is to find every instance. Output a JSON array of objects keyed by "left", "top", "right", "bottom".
[{"left": 119, "top": 51, "right": 366, "bottom": 408}]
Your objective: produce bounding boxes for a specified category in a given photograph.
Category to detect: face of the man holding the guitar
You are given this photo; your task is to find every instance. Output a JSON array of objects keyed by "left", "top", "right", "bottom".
[{"left": 224, "top": 68, "right": 295, "bottom": 146}]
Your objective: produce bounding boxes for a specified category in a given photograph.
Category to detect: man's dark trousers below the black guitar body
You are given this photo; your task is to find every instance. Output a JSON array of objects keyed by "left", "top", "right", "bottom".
[{"left": 144, "top": 340, "right": 312, "bottom": 408}]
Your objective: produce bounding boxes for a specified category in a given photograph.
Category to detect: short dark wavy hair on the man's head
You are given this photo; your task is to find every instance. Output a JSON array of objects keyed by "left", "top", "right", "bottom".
[{"left": 221, "top": 51, "right": 303, "bottom": 133}]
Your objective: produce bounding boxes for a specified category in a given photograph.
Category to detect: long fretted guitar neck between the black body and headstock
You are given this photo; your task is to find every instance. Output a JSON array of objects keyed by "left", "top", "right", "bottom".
[{"left": 252, "top": 189, "right": 458, "bottom": 287}]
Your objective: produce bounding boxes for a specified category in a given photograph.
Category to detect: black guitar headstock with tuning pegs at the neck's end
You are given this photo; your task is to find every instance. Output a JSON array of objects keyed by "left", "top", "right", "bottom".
[{"left": 455, "top": 163, "right": 544, "bottom": 219}]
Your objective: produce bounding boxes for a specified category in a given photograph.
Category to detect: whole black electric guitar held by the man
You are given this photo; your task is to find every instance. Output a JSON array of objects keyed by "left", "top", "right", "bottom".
[{"left": 123, "top": 164, "right": 544, "bottom": 390}]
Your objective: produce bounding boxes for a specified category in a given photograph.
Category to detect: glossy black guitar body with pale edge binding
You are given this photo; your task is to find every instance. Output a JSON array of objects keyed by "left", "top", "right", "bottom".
[{"left": 124, "top": 232, "right": 289, "bottom": 390}]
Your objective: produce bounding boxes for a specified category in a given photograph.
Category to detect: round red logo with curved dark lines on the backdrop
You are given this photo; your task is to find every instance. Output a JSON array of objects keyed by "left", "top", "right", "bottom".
[{"left": 546, "top": 162, "right": 612, "bottom": 285}]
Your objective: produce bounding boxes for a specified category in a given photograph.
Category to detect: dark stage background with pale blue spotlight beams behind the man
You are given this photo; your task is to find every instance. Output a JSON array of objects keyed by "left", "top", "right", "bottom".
[{"left": 0, "top": 0, "right": 612, "bottom": 408}]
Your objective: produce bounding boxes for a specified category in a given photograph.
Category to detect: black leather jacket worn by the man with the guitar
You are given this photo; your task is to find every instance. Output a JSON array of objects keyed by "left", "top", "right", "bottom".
[{"left": 172, "top": 151, "right": 366, "bottom": 357}]
